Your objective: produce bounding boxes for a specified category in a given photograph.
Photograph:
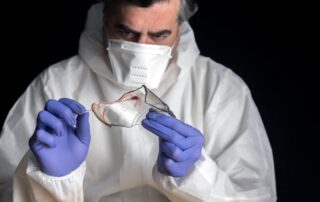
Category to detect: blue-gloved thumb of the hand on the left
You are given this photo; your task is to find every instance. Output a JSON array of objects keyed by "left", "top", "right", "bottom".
[{"left": 76, "top": 112, "right": 91, "bottom": 145}]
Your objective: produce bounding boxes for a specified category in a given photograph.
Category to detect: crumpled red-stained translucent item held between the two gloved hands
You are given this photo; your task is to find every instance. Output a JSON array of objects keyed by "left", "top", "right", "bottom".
[{"left": 91, "top": 85, "right": 175, "bottom": 128}]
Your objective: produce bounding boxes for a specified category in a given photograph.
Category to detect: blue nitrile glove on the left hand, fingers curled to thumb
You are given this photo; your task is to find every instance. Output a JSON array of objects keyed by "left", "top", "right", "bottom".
[{"left": 29, "top": 98, "right": 90, "bottom": 176}]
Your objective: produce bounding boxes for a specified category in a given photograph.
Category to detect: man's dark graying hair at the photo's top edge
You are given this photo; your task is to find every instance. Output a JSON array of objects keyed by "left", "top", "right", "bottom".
[{"left": 103, "top": 0, "right": 198, "bottom": 23}]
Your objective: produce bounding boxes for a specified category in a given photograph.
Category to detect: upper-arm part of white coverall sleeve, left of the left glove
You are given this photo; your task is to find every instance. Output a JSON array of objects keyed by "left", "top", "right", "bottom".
[{"left": 0, "top": 74, "right": 48, "bottom": 201}]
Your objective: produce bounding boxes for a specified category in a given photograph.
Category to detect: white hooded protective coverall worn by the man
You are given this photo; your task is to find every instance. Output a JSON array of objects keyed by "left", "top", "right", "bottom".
[{"left": 0, "top": 1, "right": 276, "bottom": 202}]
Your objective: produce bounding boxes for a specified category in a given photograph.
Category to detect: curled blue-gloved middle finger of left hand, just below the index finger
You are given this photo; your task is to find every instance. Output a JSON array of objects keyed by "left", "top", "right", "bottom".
[{"left": 45, "top": 100, "right": 77, "bottom": 126}]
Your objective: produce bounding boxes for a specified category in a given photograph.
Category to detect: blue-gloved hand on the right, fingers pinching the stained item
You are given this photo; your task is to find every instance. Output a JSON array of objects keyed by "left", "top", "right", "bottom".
[{"left": 142, "top": 109, "right": 204, "bottom": 177}]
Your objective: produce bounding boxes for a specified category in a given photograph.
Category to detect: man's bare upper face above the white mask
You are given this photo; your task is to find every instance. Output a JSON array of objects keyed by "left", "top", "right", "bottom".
[{"left": 105, "top": 0, "right": 180, "bottom": 46}]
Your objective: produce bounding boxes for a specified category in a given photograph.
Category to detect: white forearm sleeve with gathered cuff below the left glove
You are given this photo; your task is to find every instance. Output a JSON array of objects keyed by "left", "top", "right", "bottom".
[{"left": 13, "top": 151, "right": 86, "bottom": 202}]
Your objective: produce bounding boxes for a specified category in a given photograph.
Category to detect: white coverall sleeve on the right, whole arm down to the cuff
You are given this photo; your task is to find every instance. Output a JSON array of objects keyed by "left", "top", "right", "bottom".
[{"left": 153, "top": 71, "right": 276, "bottom": 202}]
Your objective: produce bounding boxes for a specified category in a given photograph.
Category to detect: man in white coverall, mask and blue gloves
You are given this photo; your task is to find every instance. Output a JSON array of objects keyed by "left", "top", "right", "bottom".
[{"left": 0, "top": 0, "right": 276, "bottom": 201}]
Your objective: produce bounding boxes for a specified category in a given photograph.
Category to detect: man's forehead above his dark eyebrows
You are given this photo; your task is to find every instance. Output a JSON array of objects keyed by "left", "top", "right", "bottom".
[{"left": 108, "top": 0, "right": 180, "bottom": 26}]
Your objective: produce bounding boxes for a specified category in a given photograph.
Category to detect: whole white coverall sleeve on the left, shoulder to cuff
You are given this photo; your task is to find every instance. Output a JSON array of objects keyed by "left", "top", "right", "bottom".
[{"left": 0, "top": 68, "right": 85, "bottom": 202}]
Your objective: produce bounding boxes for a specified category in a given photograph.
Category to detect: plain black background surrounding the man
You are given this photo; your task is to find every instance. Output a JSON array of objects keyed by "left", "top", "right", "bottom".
[{"left": 0, "top": 0, "right": 320, "bottom": 201}]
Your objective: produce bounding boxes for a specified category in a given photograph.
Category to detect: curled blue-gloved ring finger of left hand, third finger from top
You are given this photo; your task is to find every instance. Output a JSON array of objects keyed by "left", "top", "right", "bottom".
[{"left": 37, "top": 110, "right": 64, "bottom": 136}]
